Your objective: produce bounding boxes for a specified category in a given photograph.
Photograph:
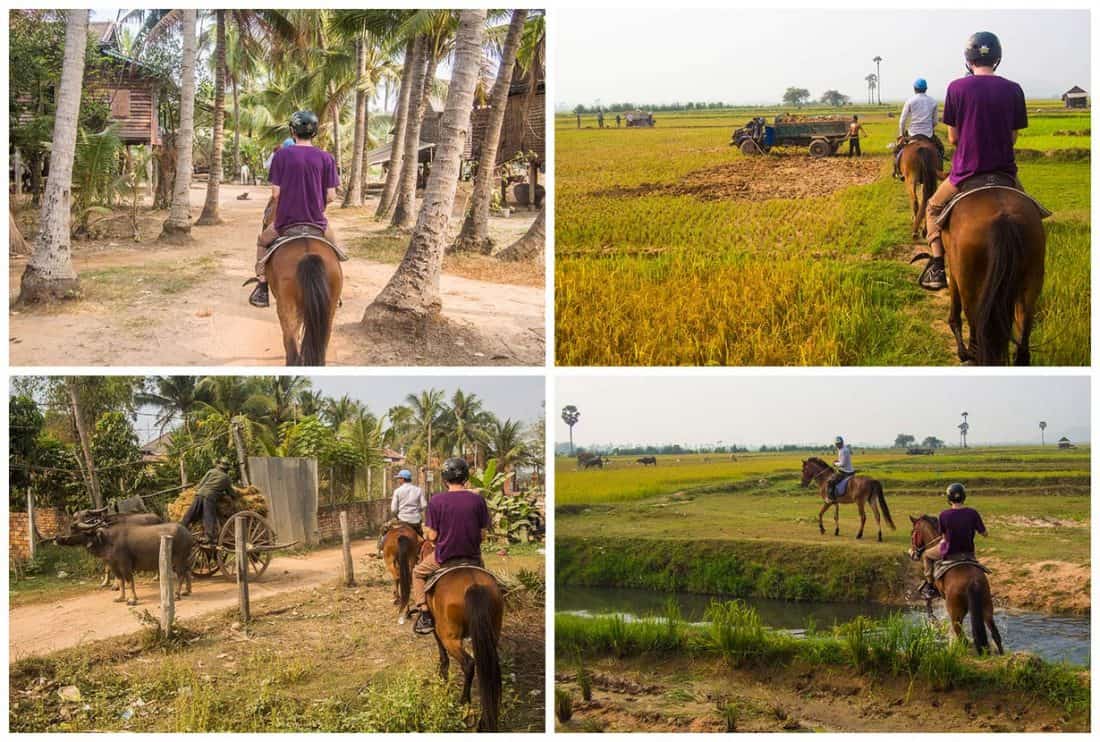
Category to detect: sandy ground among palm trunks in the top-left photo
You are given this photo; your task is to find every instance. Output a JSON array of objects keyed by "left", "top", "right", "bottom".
[{"left": 9, "top": 185, "right": 546, "bottom": 366}]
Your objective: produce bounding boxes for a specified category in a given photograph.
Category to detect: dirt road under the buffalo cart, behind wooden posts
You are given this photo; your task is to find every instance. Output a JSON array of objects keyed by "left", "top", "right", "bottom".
[{"left": 8, "top": 541, "right": 365, "bottom": 661}]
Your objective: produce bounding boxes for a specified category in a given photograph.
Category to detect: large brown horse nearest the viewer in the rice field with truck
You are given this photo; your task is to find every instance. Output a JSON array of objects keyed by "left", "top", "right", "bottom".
[{"left": 943, "top": 188, "right": 1046, "bottom": 366}]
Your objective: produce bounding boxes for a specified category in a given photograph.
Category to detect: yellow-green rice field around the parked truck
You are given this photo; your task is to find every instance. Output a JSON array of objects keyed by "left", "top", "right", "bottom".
[{"left": 554, "top": 101, "right": 1091, "bottom": 366}]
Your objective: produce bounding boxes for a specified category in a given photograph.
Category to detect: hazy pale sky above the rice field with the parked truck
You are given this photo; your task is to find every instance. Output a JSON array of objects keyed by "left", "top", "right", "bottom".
[{"left": 553, "top": 8, "right": 1091, "bottom": 108}]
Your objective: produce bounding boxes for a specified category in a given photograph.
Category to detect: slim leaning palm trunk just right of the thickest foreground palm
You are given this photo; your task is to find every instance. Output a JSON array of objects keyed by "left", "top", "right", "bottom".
[{"left": 454, "top": 10, "right": 527, "bottom": 255}]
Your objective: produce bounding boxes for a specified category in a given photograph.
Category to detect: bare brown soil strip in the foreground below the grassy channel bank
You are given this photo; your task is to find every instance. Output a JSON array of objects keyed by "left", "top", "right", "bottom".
[{"left": 557, "top": 657, "right": 1088, "bottom": 732}]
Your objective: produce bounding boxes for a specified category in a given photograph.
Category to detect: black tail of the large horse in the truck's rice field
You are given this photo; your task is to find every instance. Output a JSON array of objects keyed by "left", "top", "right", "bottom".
[{"left": 975, "top": 214, "right": 1026, "bottom": 366}]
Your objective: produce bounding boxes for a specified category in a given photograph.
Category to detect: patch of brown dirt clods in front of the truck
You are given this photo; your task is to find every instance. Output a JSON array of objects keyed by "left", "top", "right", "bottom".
[{"left": 596, "top": 155, "right": 882, "bottom": 201}]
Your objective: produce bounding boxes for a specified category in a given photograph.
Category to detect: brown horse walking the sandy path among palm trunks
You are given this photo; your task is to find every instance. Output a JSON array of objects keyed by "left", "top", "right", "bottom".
[{"left": 264, "top": 201, "right": 343, "bottom": 366}]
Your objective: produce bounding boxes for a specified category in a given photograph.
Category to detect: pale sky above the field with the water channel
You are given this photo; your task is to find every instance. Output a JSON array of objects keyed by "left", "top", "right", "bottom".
[{"left": 553, "top": 376, "right": 1090, "bottom": 447}]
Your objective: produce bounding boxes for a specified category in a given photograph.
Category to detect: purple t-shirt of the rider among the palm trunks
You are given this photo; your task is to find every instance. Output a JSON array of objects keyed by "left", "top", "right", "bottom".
[{"left": 267, "top": 145, "right": 340, "bottom": 232}]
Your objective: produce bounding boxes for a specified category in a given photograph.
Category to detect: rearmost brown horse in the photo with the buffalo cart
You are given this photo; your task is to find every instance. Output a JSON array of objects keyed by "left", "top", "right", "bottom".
[{"left": 428, "top": 567, "right": 504, "bottom": 732}]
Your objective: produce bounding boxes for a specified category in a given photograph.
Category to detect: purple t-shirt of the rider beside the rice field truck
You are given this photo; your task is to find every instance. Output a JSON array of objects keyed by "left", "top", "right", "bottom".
[{"left": 944, "top": 75, "right": 1027, "bottom": 186}]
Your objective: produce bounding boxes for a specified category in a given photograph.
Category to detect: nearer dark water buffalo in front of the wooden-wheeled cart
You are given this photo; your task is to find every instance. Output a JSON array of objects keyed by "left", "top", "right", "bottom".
[{"left": 56, "top": 520, "right": 194, "bottom": 606}]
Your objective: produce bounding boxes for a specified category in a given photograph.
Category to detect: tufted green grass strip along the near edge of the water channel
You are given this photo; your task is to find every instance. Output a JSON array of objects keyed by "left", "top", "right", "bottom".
[{"left": 554, "top": 602, "right": 1090, "bottom": 726}]
